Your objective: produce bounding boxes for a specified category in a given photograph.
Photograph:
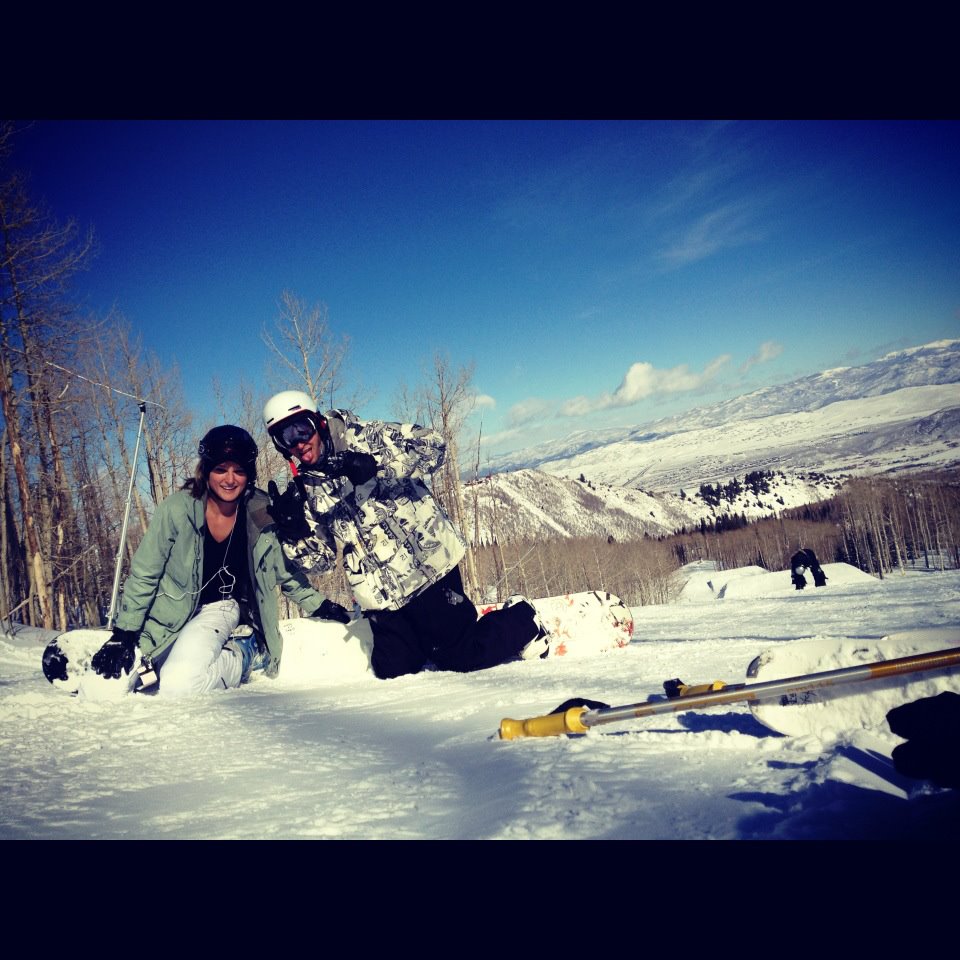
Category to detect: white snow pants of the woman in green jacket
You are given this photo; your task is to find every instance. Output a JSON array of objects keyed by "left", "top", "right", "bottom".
[{"left": 159, "top": 600, "right": 243, "bottom": 697}]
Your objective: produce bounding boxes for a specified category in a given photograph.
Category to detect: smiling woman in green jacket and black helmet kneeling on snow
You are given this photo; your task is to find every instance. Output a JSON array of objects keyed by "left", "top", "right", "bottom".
[{"left": 91, "top": 424, "right": 349, "bottom": 696}]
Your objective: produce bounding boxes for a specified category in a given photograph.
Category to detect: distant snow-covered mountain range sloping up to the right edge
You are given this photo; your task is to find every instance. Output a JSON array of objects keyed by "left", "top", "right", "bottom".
[{"left": 490, "top": 340, "right": 960, "bottom": 492}]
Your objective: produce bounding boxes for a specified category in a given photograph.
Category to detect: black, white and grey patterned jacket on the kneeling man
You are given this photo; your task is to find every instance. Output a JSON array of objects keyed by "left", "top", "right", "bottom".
[{"left": 283, "top": 410, "right": 465, "bottom": 610}]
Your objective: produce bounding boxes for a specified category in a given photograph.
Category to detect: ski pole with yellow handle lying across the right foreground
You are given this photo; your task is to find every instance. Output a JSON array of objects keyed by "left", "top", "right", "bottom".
[{"left": 500, "top": 647, "right": 960, "bottom": 740}]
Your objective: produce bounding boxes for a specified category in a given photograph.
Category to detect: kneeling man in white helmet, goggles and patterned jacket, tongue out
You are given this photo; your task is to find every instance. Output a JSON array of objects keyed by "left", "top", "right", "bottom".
[{"left": 263, "top": 390, "right": 548, "bottom": 679}]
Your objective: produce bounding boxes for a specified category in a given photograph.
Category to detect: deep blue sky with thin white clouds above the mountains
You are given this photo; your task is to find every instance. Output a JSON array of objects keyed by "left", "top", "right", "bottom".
[{"left": 14, "top": 121, "right": 960, "bottom": 462}]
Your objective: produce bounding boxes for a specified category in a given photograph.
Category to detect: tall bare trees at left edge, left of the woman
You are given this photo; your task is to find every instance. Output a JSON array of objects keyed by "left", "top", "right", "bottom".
[{"left": 0, "top": 124, "right": 197, "bottom": 629}]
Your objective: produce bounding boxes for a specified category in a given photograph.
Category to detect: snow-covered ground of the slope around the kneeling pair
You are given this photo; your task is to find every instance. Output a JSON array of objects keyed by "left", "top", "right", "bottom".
[{"left": 0, "top": 564, "right": 960, "bottom": 839}]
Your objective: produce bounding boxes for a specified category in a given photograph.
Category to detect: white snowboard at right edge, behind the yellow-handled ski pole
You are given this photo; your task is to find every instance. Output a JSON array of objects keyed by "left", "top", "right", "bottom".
[{"left": 747, "top": 627, "right": 960, "bottom": 739}]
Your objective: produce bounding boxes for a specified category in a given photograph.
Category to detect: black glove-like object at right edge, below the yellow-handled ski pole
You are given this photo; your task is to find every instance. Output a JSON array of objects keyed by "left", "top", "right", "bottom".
[{"left": 887, "top": 692, "right": 960, "bottom": 789}]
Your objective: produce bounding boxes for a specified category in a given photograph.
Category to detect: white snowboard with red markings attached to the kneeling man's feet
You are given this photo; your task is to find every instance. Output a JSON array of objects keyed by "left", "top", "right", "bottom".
[{"left": 478, "top": 590, "right": 633, "bottom": 657}]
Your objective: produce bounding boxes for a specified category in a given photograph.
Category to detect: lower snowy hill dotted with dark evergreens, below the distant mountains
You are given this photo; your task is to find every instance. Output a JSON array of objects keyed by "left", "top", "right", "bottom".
[{"left": 464, "top": 470, "right": 842, "bottom": 543}]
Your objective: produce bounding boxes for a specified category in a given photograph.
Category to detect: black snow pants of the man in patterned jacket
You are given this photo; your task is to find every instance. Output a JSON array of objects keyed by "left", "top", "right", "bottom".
[{"left": 365, "top": 567, "right": 537, "bottom": 680}]
